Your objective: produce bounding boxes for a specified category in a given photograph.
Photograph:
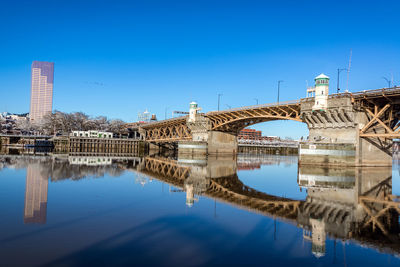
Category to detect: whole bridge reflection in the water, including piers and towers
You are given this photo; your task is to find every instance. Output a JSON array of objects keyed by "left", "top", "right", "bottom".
[{"left": 138, "top": 157, "right": 400, "bottom": 256}]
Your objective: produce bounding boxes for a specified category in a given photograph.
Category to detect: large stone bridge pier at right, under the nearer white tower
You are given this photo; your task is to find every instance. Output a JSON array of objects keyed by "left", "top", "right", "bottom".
[{"left": 299, "top": 97, "right": 392, "bottom": 166}]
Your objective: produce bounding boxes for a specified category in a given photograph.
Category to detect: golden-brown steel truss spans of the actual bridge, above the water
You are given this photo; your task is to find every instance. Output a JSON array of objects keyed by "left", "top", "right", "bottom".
[{"left": 138, "top": 87, "right": 400, "bottom": 143}]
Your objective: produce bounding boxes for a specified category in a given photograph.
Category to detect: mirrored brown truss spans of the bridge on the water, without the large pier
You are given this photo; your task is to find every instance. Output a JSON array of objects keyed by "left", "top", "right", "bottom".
[{"left": 138, "top": 157, "right": 400, "bottom": 255}]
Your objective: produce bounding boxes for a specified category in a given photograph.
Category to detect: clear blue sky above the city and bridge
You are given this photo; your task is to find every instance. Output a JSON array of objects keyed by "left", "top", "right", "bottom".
[{"left": 0, "top": 0, "right": 400, "bottom": 137}]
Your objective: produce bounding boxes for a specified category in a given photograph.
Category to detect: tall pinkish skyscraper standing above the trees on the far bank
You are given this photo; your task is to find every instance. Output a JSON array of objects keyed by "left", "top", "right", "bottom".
[{"left": 29, "top": 61, "right": 54, "bottom": 121}]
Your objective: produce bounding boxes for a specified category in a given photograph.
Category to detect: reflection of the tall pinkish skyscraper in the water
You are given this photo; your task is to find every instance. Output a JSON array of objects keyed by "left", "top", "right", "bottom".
[{"left": 24, "top": 165, "right": 49, "bottom": 223}]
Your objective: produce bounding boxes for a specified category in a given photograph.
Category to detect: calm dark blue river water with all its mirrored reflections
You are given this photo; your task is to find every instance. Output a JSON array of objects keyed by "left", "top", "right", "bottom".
[{"left": 0, "top": 152, "right": 400, "bottom": 266}]
